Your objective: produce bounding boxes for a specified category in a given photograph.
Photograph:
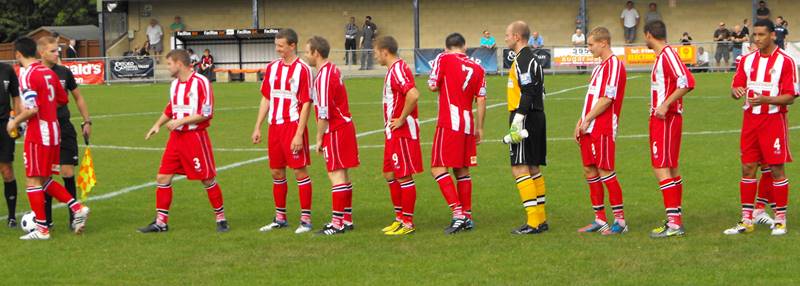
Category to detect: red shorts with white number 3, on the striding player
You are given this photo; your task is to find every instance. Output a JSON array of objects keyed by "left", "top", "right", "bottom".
[{"left": 158, "top": 130, "right": 217, "bottom": 180}]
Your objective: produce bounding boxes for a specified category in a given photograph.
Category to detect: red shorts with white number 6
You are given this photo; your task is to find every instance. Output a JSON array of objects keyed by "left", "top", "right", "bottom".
[{"left": 650, "top": 113, "right": 683, "bottom": 168}]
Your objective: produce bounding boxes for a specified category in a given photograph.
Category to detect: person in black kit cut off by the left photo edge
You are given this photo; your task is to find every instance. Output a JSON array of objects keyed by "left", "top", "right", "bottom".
[{"left": 0, "top": 63, "right": 20, "bottom": 228}]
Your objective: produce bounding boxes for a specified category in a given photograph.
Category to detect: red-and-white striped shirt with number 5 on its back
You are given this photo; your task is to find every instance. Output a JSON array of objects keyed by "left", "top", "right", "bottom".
[{"left": 19, "top": 62, "right": 62, "bottom": 146}]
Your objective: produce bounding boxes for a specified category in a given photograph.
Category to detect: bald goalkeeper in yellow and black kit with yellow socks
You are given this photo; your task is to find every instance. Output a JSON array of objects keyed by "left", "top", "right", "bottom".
[{"left": 503, "top": 21, "right": 548, "bottom": 234}]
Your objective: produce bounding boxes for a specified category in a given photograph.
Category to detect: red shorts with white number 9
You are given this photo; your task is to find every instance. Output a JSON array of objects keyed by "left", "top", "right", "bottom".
[{"left": 383, "top": 136, "right": 423, "bottom": 178}]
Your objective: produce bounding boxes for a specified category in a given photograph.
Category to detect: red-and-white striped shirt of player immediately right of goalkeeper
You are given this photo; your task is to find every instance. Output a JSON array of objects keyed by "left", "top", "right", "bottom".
[{"left": 581, "top": 55, "right": 627, "bottom": 137}]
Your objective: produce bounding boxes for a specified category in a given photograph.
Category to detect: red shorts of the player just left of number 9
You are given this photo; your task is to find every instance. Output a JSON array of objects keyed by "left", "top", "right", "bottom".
[{"left": 322, "top": 123, "right": 359, "bottom": 172}]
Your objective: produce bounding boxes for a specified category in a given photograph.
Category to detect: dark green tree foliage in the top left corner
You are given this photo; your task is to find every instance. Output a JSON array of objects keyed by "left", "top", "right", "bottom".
[{"left": 0, "top": 0, "right": 98, "bottom": 42}]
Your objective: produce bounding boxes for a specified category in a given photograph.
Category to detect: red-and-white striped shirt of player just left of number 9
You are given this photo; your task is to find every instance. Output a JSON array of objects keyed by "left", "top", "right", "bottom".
[{"left": 314, "top": 62, "right": 353, "bottom": 133}]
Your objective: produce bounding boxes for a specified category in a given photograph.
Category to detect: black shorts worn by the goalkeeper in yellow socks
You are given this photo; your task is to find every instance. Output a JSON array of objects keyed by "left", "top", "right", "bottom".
[{"left": 508, "top": 111, "right": 547, "bottom": 166}]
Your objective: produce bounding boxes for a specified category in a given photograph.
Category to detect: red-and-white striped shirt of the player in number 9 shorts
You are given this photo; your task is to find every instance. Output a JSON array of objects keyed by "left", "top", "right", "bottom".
[{"left": 383, "top": 59, "right": 419, "bottom": 140}]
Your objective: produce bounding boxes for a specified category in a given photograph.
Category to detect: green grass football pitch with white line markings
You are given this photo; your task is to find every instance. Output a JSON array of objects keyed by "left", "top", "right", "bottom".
[{"left": 0, "top": 73, "right": 800, "bottom": 285}]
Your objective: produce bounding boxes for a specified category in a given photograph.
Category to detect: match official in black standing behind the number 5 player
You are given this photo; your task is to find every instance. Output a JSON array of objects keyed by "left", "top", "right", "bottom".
[{"left": 37, "top": 37, "right": 92, "bottom": 228}]
